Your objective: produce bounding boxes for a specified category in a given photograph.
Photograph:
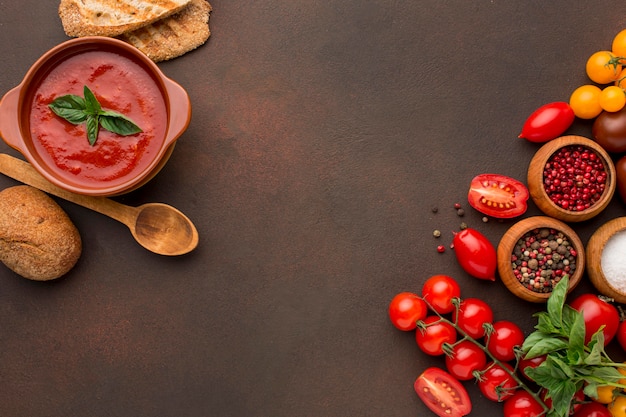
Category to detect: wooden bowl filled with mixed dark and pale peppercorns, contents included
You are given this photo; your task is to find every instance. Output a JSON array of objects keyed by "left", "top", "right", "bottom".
[{"left": 497, "top": 216, "right": 585, "bottom": 303}]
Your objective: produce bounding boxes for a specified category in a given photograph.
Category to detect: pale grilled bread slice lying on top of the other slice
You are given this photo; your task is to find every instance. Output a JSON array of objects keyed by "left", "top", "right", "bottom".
[{"left": 59, "top": 0, "right": 191, "bottom": 37}]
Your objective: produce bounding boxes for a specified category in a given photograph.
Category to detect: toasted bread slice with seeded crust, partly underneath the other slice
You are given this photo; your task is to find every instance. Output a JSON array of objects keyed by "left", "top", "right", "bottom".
[{"left": 119, "top": 0, "right": 211, "bottom": 62}]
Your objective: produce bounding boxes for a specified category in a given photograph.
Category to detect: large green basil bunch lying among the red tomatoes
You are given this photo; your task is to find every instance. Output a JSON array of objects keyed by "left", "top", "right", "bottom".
[{"left": 522, "top": 277, "right": 626, "bottom": 417}]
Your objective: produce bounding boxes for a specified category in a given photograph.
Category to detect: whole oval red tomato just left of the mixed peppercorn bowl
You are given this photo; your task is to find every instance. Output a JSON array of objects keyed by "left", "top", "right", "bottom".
[{"left": 452, "top": 227, "right": 497, "bottom": 281}]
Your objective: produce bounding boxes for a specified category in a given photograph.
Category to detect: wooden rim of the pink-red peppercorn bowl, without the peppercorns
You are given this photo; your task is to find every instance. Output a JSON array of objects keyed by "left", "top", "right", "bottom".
[{"left": 528, "top": 135, "right": 616, "bottom": 222}]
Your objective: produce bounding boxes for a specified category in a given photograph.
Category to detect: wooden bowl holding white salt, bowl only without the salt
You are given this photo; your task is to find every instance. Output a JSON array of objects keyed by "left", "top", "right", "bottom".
[{"left": 586, "top": 217, "right": 626, "bottom": 303}]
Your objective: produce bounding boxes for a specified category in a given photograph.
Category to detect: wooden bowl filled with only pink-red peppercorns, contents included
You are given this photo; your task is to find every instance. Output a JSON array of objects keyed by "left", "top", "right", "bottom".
[{"left": 528, "top": 136, "right": 616, "bottom": 222}]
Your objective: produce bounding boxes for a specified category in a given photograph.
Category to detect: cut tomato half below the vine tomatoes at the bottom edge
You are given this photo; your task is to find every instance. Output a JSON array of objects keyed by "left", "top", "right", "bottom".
[{"left": 413, "top": 367, "right": 472, "bottom": 417}]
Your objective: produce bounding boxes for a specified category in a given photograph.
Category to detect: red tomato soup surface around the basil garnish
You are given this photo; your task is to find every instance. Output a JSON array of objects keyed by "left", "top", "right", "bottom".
[{"left": 30, "top": 51, "right": 167, "bottom": 187}]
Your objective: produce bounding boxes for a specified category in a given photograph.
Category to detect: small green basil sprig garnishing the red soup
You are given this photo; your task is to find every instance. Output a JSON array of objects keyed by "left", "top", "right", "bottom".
[{"left": 48, "top": 86, "right": 142, "bottom": 146}]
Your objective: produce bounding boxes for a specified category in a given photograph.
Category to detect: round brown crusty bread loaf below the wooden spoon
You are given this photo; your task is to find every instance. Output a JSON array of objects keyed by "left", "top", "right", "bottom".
[{"left": 0, "top": 185, "right": 82, "bottom": 281}]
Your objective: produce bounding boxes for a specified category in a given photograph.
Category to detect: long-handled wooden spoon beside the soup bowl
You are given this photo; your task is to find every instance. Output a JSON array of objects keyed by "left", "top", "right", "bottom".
[{"left": 0, "top": 153, "right": 198, "bottom": 256}]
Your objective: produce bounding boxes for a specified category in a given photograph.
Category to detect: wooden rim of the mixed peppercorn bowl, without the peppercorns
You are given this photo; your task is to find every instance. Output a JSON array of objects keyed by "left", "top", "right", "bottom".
[{"left": 497, "top": 216, "right": 585, "bottom": 303}]
